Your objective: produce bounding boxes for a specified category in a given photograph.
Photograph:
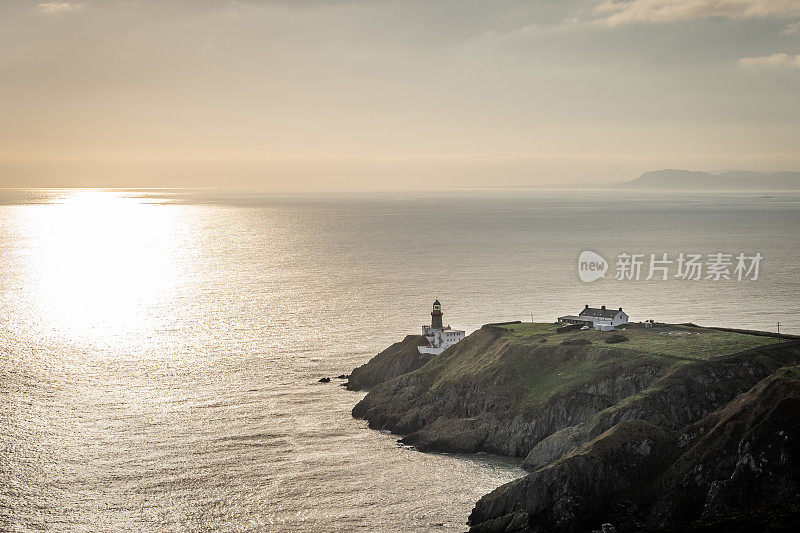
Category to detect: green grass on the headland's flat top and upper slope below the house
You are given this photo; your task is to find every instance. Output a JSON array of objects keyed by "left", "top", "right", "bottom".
[{"left": 404, "top": 323, "right": 781, "bottom": 412}]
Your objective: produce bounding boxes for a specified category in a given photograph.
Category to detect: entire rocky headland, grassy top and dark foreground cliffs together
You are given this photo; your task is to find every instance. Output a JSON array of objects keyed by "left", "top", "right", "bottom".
[{"left": 353, "top": 324, "right": 800, "bottom": 531}]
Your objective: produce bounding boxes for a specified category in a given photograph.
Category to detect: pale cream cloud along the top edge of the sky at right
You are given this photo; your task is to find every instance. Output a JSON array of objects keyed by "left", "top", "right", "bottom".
[{"left": 594, "top": 0, "right": 800, "bottom": 26}]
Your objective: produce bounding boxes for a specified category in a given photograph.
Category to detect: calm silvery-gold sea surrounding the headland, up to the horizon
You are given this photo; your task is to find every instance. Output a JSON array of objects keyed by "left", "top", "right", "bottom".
[{"left": 0, "top": 190, "right": 800, "bottom": 531}]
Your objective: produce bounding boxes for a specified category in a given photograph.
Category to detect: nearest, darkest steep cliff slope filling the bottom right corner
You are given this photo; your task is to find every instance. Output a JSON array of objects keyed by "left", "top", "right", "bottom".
[{"left": 648, "top": 367, "right": 800, "bottom": 527}]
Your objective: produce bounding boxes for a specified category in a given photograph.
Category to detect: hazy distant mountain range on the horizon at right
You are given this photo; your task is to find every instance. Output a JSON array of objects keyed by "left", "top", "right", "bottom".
[{"left": 620, "top": 169, "right": 800, "bottom": 191}]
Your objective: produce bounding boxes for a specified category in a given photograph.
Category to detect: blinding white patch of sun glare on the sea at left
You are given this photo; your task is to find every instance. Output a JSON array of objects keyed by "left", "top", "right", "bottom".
[{"left": 12, "top": 190, "right": 186, "bottom": 343}]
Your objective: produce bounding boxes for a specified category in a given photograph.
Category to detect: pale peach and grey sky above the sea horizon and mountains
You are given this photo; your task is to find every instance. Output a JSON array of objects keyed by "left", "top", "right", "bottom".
[{"left": 0, "top": 0, "right": 800, "bottom": 191}]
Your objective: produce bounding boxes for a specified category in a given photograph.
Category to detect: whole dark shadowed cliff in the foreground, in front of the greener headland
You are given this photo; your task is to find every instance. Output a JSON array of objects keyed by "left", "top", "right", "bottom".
[{"left": 462, "top": 353, "right": 800, "bottom": 532}]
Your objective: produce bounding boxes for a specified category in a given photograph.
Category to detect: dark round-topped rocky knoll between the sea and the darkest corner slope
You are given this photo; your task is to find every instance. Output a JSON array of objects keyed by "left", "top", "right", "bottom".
[{"left": 469, "top": 421, "right": 675, "bottom": 532}]
